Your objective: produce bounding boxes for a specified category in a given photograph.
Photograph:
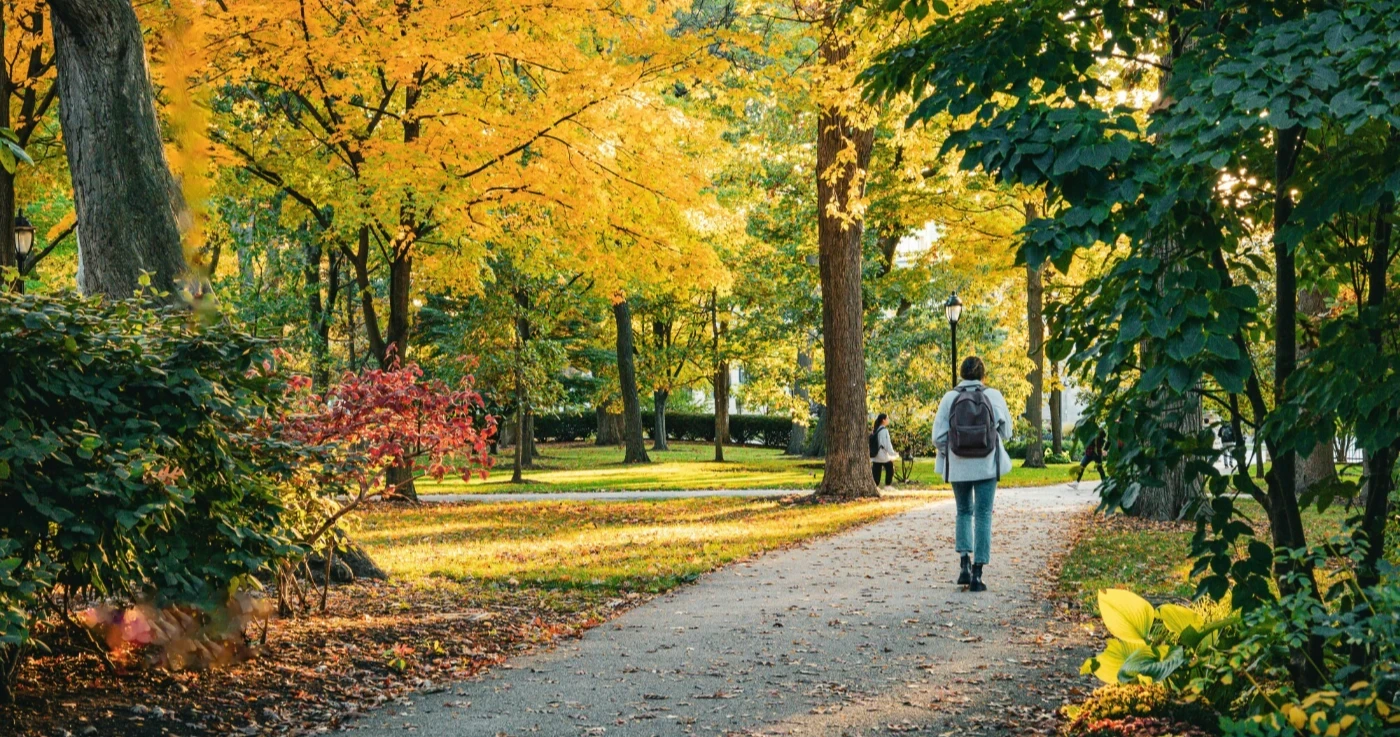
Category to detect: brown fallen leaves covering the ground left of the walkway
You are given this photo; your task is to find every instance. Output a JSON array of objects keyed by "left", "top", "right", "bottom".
[{"left": 0, "top": 581, "right": 641, "bottom": 737}]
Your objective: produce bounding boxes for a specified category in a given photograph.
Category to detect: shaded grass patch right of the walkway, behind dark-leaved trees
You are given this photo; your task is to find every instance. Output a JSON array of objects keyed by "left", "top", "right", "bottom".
[{"left": 1058, "top": 499, "right": 1347, "bottom": 614}]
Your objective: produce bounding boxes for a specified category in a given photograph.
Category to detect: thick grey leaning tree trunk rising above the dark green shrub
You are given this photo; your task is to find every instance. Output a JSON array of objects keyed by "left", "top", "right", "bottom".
[{"left": 50, "top": 0, "right": 188, "bottom": 298}]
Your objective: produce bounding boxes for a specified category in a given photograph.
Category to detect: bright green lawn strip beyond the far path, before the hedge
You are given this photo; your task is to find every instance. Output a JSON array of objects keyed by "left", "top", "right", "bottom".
[{"left": 417, "top": 443, "right": 1098, "bottom": 495}]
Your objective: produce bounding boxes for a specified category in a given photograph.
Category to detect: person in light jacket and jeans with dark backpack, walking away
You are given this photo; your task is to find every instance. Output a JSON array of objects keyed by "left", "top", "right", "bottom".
[{"left": 934, "top": 356, "right": 1011, "bottom": 591}]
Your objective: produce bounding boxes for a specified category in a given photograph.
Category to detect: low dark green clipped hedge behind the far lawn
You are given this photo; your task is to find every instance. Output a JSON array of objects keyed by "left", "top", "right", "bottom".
[{"left": 535, "top": 412, "right": 792, "bottom": 448}]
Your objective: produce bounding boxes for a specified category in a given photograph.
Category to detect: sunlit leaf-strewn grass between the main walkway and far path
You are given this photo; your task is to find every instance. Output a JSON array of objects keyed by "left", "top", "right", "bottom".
[{"left": 356, "top": 493, "right": 932, "bottom": 608}]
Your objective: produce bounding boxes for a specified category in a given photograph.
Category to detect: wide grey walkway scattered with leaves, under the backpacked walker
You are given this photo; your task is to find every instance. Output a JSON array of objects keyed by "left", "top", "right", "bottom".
[{"left": 357, "top": 485, "right": 1096, "bottom": 737}]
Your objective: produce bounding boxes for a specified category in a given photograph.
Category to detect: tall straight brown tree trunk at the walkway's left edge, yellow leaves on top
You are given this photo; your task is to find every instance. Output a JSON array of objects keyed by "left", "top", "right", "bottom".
[{"left": 816, "top": 27, "right": 879, "bottom": 500}]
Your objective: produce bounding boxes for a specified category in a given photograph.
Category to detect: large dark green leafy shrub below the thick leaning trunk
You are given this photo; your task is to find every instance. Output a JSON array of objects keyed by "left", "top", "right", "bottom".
[{"left": 0, "top": 293, "right": 295, "bottom": 696}]
